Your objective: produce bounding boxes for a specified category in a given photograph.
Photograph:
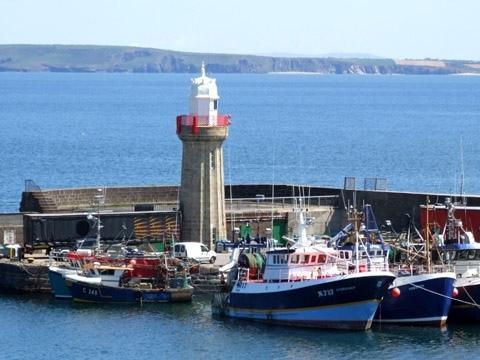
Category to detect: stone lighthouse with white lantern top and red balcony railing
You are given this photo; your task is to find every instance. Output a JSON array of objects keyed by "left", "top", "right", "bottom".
[{"left": 177, "top": 63, "right": 230, "bottom": 248}]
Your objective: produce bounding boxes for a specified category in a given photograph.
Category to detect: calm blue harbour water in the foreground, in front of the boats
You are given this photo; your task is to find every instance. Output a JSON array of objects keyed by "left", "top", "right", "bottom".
[{"left": 0, "top": 295, "right": 480, "bottom": 360}]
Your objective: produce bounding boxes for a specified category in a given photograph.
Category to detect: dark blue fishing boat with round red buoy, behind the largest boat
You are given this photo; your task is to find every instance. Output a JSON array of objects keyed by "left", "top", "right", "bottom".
[{"left": 333, "top": 204, "right": 455, "bottom": 326}]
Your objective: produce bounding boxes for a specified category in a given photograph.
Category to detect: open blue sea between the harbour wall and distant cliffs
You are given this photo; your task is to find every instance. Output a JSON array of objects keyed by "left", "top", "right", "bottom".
[{"left": 0, "top": 73, "right": 480, "bottom": 212}]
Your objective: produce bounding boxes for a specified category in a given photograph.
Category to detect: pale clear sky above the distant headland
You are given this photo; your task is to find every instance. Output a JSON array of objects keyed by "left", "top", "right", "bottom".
[{"left": 0, "top": 0, "right": 480, "bottom": 60}]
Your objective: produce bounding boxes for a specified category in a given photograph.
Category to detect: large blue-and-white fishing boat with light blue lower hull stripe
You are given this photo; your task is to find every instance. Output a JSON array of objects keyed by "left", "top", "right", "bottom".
[{"left": 212, "top": 205, "right": 395, "bottom": 329}]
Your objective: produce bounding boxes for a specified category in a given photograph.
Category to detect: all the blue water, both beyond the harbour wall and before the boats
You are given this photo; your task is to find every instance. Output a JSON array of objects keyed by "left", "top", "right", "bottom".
[{"left": 0, "top": 73, "right": 480, "bottom": 360}]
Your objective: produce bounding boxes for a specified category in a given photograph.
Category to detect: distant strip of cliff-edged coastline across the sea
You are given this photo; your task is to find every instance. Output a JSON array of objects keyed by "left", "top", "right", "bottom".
[{"left": 0, "top": 45, "right": 480, "bottom": 74}]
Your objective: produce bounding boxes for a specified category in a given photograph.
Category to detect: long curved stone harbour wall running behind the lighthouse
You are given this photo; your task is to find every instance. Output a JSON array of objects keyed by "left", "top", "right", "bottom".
[{"left": 14, "top": 184, "right": 480, "bottom": 243}]
